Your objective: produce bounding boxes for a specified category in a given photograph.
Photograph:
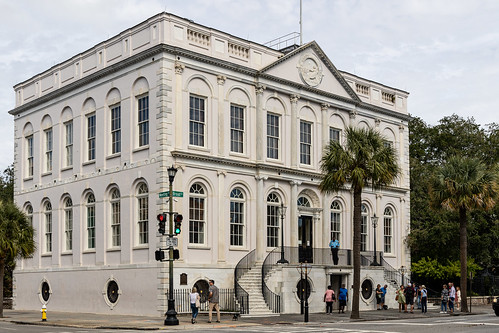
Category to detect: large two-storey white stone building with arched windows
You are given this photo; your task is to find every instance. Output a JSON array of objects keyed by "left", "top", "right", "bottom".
[{"left": 9, "top": 13, "right": 410, "bottom": 315}]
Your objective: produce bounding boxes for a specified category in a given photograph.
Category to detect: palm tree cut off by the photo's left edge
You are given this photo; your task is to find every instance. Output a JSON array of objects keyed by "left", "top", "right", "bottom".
[{"left": 0, "top": 201, "right": 35, "bottom": 318}]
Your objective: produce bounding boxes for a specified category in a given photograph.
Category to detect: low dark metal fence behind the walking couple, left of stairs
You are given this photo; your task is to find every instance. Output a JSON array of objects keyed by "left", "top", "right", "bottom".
[{"left": 166, "top": 288, "right": 240, "bottom": 313}]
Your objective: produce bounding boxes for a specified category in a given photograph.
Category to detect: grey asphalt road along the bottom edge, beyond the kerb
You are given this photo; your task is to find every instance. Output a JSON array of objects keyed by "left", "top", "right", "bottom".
[{"left": 0, "top": 313, "right": 499, "bottom": 333}]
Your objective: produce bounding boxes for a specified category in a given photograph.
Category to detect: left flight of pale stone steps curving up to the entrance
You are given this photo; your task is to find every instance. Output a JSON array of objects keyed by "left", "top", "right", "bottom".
[{"left": 238, "top": 264, "right": 279, "bottom": 317}]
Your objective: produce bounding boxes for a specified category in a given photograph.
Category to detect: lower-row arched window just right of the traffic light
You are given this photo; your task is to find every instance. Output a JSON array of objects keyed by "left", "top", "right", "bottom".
[{"left": 189, "top": 184, "right": 206, "bottom": 244}]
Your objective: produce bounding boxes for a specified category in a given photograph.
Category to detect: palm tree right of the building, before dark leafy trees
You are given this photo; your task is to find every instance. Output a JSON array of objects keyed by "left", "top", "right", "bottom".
[{"left": 430, "top": 156, "right": 498, "bottom": 312}]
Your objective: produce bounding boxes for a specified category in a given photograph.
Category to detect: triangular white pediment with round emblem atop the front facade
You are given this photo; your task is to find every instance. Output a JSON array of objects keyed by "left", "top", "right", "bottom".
[{"left": 260, "top": 42, "right": 360, "bottom": 101}]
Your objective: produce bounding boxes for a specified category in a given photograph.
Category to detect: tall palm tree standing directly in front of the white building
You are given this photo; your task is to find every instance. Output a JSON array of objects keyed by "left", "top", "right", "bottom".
[{"left": 319, "top": 127, "right": 400, "bottom": 319}]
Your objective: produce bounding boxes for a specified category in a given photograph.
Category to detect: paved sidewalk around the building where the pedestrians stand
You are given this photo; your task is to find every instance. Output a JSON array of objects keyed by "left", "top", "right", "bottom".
[{"left": 0, "top": 306, "right": 492, "bottom": 330}]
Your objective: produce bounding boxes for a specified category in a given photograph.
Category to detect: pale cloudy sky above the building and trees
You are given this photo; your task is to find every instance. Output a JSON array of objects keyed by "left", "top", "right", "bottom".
[{"left": 0, "top": 0, "right": 499, "bottom": 171}]
